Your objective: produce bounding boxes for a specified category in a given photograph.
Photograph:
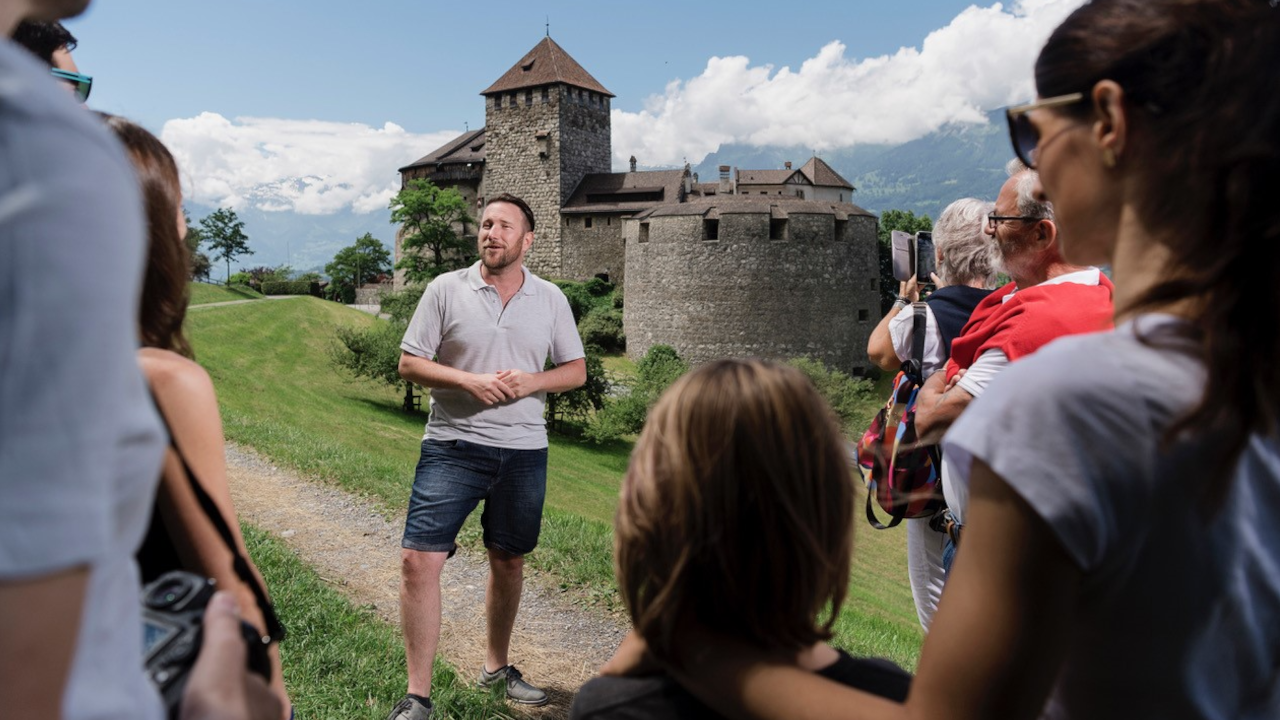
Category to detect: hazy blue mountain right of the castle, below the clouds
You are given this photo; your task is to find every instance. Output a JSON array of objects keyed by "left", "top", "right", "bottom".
[{"left": 694, "top": 110, "right": 1012, "bottom": 220}]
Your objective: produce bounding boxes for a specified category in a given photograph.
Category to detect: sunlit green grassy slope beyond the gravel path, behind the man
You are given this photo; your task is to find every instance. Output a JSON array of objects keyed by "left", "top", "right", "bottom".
[{"left": 188, "top": 296, "right": 920, "bottom": 707}]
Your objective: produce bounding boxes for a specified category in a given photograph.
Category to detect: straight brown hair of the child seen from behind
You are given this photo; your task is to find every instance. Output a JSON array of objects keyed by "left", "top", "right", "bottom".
[{"left": 614, "top": 360, "right": 855, "bottom": 657}]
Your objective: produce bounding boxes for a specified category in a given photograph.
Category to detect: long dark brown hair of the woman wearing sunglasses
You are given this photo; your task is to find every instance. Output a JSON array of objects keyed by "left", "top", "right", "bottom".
[{"left": 1036, "top": 0, "right": 1280, "bottom": 471}]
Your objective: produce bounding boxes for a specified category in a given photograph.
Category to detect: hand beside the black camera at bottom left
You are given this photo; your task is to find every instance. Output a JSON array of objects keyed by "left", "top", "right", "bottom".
[{"left": 179, "top": 591, "right": 283, "bottom": 720}]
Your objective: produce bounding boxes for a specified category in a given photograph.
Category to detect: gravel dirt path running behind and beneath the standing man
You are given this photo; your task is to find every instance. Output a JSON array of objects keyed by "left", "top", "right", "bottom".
[{"left": 227, "top": 443, "right": 626, "bottom": 717}]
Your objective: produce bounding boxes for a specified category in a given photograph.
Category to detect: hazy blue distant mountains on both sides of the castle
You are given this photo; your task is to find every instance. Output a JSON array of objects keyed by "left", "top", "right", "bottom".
[{"left": 194, "top": 110, "right": 1012, "bottom": 279}]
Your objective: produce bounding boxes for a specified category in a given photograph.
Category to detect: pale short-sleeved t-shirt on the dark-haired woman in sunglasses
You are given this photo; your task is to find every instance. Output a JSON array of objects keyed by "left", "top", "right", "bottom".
[{"left": 943, "top": 316, "right": 1280, "bottom": 720}]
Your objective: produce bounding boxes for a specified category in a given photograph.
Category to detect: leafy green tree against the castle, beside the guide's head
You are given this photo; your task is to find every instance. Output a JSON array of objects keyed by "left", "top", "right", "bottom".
[{"left": 390, "top": 179, "right": 476, "bottom": 283}]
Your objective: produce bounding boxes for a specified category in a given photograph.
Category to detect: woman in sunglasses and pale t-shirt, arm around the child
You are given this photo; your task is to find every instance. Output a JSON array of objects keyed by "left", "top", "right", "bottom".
[{"left": 606, "top": 0, "right": 1280, "bottom": 720}]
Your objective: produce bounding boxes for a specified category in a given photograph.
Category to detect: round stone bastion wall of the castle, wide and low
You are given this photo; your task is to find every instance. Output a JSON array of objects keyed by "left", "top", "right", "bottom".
[{"left": 623, "top": 210, "right": 879, "bottom": 374}]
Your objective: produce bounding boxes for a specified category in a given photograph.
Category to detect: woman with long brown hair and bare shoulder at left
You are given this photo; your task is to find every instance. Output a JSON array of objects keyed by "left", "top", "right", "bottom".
[{"left": 102, "top": 114, "right": 291, "bottom": 717}]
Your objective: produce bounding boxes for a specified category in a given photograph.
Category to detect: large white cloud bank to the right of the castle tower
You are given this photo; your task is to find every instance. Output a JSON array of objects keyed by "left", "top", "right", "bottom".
[{"left": 613, "top": 0, "right": 1083, "bottom": 168}]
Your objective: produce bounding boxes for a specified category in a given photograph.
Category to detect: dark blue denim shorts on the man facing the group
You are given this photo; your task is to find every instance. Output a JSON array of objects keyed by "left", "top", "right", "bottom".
[{"left": 401, "top": 439, "right": 547, "bottom": 555}]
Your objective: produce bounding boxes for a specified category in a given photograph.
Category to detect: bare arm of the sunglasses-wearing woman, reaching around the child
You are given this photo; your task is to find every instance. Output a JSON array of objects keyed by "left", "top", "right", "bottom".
[{"left": 671, "top": 461, "right": 1082, "bottom": 720}]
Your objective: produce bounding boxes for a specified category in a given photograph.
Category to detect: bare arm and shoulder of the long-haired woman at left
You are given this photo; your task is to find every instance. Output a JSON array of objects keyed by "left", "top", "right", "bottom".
[{"left": 140, "top": 350, "right": 289, "bottom": 719}]
